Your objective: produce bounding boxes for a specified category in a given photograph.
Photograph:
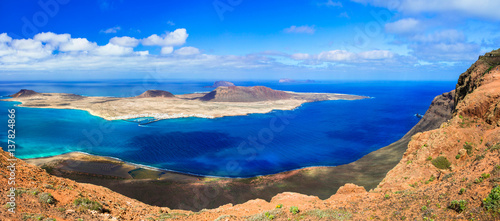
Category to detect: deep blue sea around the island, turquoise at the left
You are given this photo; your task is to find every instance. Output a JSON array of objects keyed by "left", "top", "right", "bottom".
[{"left": 0, "top": 80, "right": 456, "bottom": 177}]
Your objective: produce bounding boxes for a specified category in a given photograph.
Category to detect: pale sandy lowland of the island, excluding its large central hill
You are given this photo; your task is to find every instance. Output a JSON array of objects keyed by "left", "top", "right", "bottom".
[{"left": 1, "top": 92, "right": 369, "bottom": 120}]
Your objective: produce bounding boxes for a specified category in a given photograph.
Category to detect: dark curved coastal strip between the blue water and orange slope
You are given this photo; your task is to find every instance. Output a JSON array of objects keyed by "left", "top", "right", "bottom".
[{"left": 20, "top": 90, "right": 453, "bottom": 211}]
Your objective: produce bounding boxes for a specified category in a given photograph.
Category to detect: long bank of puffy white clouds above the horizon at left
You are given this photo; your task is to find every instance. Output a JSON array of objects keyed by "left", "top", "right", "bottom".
[{"left": 0, "top": 31, "right": 278, "bottom": 73}]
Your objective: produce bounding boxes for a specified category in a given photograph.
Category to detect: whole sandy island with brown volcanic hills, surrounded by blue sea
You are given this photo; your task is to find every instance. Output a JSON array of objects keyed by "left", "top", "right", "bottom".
[{"left": 4, "top": 86, "right": 368, "bottom": 120}]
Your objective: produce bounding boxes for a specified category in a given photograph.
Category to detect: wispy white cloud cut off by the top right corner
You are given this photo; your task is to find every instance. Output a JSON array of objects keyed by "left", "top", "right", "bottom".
[{"left": 351, "top": 0, "right": 500, "bottom": 20}]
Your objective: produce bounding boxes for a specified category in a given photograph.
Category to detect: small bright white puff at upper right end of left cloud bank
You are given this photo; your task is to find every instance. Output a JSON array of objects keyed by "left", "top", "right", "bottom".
[{"left": 142, "top": 28, "right": 189, "bottom": 47}]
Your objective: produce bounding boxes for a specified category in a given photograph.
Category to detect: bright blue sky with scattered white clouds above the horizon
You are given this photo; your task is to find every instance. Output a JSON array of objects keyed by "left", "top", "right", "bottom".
[{"left": 0, "top": 0, "right": 500, "bottom": 81}]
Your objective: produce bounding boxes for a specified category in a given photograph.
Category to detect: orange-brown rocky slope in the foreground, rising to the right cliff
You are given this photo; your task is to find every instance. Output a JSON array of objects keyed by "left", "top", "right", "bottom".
[{"left": 0, "top": 51, "right": 500, "bottom": 221}]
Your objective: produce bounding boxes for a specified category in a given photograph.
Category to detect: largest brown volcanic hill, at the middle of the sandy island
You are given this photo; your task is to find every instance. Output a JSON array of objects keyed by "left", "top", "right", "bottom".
[{"left": 200, "top": 86, "right": 292, "bottom": 102}]
